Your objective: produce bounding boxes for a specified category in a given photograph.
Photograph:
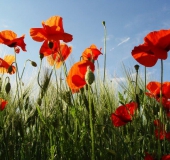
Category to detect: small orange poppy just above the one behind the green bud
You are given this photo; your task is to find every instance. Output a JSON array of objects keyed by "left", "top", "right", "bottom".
[{"left": 82, "top": 44, "right": 102, "bottom": 61}]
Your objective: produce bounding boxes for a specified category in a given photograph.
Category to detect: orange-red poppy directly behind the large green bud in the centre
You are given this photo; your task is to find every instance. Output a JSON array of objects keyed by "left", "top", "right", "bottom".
[{"left": 67, "top": 60, "right": 95, "bottom": 93}]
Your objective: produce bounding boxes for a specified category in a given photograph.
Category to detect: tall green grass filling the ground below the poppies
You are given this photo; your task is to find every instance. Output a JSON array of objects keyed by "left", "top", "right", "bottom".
[{"left": 0, "top": 60, "right": 170, "bottom": 160}]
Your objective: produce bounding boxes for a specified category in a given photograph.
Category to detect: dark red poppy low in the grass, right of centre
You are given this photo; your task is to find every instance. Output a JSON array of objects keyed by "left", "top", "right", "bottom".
[{"left": 111, "top": 102, "right": 137, "bottom": 127}]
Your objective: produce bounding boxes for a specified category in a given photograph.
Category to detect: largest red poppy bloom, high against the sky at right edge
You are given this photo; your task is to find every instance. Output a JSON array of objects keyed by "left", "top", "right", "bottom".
[{"left": 132, "top": 30, "right": 170, "bottom": 67}]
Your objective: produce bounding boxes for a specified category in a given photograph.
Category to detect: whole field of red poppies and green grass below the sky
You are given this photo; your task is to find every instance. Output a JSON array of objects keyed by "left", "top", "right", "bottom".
[{"left": 0, "top": 16, "right": 170, "bottom": 160}]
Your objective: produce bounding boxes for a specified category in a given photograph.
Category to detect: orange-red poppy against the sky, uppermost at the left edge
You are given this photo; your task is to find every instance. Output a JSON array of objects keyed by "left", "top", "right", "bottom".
[{"left": 0, "top": 30, "right": 26, "bottom": 51}]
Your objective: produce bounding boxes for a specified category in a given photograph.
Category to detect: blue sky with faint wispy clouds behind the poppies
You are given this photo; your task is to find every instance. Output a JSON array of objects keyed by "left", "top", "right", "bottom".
[{"left": 0, "top": 0, "right": 170, "bottom": 81}]
